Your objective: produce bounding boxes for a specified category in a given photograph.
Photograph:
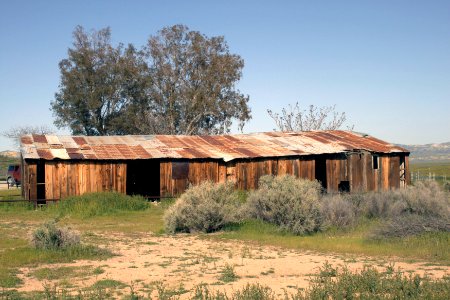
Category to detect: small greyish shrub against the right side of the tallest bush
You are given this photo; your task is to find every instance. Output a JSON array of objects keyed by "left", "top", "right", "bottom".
[{"left": 321, "top": 194, "right": 357, "bottom": 227}]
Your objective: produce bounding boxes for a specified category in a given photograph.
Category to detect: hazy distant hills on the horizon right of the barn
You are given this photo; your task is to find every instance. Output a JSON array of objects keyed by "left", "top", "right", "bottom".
[{"left": 399, "top": 142, "right": 450, "bottom": 161}]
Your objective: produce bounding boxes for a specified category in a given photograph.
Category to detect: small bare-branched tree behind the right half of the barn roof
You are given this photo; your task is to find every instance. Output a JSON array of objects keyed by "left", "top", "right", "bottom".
[{"left": 267, "top": 102, "right": 354, "bottom": 131}]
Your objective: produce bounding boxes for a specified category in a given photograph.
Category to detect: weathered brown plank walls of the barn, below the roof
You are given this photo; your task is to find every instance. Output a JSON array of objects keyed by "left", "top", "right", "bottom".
[{"left": 22, "top": 152, "right": 411, "bottom": 199}]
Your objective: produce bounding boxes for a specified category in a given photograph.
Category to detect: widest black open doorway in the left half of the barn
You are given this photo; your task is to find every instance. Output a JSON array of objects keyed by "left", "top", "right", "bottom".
[{"left": 127, "top": 159, "right": 160, "bottom": 198}]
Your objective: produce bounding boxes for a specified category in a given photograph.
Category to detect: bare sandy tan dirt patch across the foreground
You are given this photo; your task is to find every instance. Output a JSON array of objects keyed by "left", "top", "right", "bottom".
[{"left": 18, "top": 234, "right": 450, "bottom": 299}]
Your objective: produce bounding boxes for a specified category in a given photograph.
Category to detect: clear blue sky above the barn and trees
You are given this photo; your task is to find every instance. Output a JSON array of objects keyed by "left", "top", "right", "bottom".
[{"left": 0, "top": 0, "right": 450, "bottom": 150}]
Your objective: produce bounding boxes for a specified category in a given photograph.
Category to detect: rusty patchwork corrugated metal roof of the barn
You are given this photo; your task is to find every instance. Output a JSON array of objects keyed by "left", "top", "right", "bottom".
[{"left": 21, "top": 130, "right": 409, "bottom": 161}]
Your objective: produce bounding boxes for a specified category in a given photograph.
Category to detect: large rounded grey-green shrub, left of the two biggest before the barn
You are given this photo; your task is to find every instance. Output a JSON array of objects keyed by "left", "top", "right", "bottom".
[{"left": 164, "top": 181, "right": 241, "bottom": 233}]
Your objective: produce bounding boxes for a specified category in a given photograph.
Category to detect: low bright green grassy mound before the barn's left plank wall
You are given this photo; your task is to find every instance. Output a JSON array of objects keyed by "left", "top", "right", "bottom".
[{"left": 49, "top": 192, "right": 149, "bottom": 218}]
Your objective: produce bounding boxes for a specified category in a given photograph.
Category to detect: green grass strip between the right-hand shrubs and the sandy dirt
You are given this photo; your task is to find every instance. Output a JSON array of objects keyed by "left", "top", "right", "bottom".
[{"left": 216, "top": 220, "right": 450, "bottom": 265}]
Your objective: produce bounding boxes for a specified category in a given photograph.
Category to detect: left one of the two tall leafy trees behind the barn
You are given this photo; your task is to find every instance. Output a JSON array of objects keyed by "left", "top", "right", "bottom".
[{"left": 51, "top": 26, "right": 141, "bottom": 135}]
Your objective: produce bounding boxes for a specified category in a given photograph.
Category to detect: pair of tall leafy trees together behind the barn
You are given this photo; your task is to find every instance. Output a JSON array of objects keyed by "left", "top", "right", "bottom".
[{"left": 51, "top": 25, "right": 251, "bottom": 135}]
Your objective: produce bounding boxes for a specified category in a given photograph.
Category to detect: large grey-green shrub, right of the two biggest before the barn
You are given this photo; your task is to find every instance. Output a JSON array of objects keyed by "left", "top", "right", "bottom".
[{"left": 245, "top": 175, "right": 323, "bottom": 235}]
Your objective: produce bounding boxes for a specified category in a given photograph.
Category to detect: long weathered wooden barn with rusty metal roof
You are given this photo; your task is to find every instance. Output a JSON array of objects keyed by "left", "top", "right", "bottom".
[{"left": 21, "top": 130, "right": 410, "bottom": 200}]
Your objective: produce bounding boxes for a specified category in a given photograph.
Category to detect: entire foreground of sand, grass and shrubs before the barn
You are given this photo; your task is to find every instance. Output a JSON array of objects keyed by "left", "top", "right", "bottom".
[{"left": 0, "top": 177, "right": 450, "bottom": 299}]
